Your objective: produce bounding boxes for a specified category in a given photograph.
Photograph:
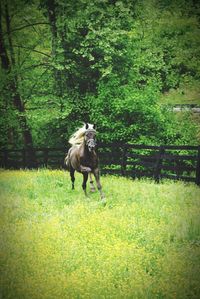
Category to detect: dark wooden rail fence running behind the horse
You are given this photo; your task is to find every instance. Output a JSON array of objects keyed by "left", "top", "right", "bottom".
[{"left": 0, "top": 143, "right": 200, "bottom": 185}]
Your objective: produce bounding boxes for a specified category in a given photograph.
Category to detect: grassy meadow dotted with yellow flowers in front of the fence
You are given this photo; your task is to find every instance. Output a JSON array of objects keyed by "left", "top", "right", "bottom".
[{"left": 0, "top": 170, "right": 200, "bottom": 299}]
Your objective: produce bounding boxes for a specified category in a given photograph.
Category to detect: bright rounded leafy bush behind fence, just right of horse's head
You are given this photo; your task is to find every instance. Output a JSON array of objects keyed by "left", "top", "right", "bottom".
[{"left": 91, "top": 78, "right": 164, "bottom": 143}]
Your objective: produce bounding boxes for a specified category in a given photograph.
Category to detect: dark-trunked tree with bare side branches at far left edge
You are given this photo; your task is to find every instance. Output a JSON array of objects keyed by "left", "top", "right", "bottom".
[{"left": 0, "top": 0, "right": 52, "bottom": 150}]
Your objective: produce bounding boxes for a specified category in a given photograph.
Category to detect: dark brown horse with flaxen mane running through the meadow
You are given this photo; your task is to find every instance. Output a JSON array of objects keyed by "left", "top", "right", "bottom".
[{"left": 64, "top": 123, "right": 106, "bottom": 204}]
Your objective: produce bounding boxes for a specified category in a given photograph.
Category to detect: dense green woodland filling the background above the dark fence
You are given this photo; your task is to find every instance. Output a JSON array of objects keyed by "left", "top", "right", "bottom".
[{"left": 0, "top": 0, "right": 200, "bottom": 148}]
